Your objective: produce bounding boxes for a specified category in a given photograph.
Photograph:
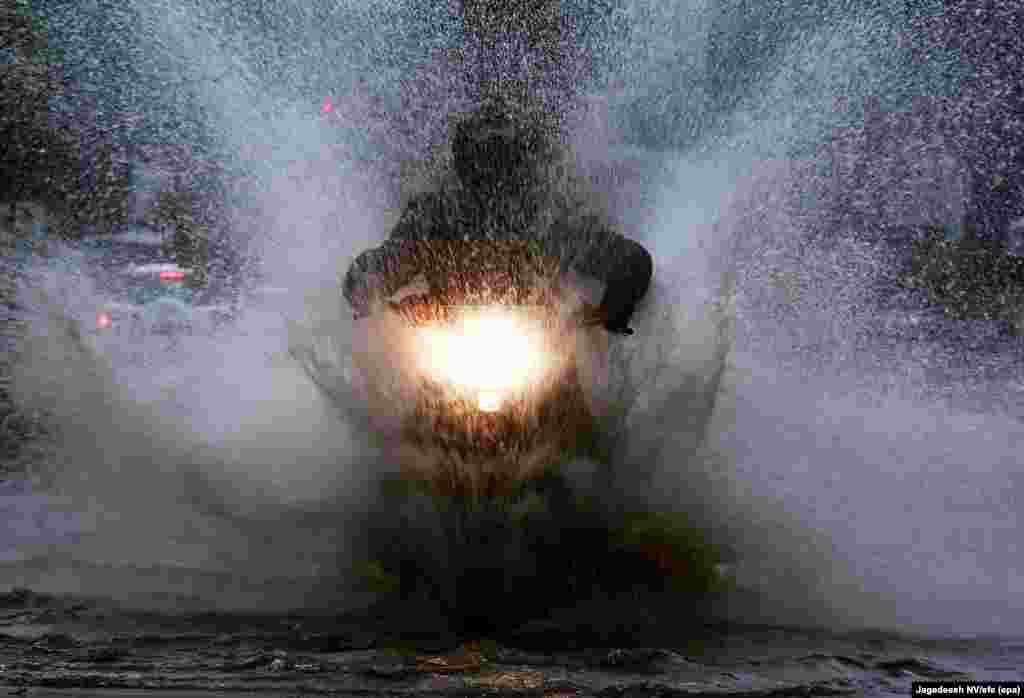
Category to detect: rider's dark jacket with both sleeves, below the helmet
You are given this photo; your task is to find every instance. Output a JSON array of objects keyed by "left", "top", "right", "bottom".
[{"left": 343, "top": 173, "right": 653, "bottom": 331}]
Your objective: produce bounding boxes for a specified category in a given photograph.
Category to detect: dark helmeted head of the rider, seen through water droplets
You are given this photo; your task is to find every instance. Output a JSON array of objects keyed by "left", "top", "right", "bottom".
[{"left": 452, "top": 101, "right": 549, "bottom": 187}]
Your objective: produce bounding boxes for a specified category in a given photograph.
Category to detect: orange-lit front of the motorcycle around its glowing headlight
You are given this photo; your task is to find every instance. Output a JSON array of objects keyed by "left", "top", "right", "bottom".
[{"left": 353, "top": 282, "right": 594, "bottom": 496}]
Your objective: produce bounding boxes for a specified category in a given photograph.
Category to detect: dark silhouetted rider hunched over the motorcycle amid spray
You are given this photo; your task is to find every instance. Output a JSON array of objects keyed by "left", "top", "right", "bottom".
[{"left": 344, "top": 97, "right": 653, "bottom": 335}]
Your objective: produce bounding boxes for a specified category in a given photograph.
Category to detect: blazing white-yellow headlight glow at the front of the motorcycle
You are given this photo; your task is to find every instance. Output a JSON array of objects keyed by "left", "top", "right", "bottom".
[{"left": 411, "top": 311, "right": 547, "bottom": 412}]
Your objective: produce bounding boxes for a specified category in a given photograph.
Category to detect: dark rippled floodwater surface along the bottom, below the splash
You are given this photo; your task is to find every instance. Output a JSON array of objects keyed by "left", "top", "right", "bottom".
[{"left": 0, "top": 594, "right": 1024, "bottom": 697}]
